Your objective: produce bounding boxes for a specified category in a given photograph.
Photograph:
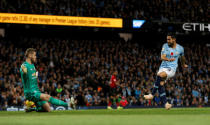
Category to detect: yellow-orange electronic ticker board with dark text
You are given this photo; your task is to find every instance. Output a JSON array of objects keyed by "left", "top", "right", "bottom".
[{"left": 0, "top": 13, "right": 123, "bottom": 28}]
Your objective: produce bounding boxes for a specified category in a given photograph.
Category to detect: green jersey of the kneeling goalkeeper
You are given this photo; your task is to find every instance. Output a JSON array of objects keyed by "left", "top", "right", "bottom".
[{"left": 20, "top": 61, "right": 39, "bottom": 93}]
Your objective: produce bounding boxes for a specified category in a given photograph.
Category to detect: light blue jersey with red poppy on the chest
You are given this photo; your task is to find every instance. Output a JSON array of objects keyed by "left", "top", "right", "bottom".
[{"left": 160, "top": 43, "right": 184, "bottom": 71}]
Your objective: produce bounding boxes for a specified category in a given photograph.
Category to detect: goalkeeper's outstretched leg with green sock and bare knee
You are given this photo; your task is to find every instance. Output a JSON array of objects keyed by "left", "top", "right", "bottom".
[{"left": 40, "top": 93, "right": 68, "bottom": 107}]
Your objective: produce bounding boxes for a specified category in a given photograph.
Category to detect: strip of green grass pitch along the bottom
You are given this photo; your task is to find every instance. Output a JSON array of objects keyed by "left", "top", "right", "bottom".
[{"left": 0, "top": 108, "right": 210, "bottom": 125}]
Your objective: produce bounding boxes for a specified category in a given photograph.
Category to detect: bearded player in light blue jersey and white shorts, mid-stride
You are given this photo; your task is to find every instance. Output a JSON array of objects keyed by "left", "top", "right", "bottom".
[{"left": 144, "top": 33, "right": 188, "bottom": 109}]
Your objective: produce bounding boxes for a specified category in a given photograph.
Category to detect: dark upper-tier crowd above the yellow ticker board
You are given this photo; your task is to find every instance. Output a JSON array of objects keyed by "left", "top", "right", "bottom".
[{"left": 0, "top": 0, "right": 209, "bottom": 22}]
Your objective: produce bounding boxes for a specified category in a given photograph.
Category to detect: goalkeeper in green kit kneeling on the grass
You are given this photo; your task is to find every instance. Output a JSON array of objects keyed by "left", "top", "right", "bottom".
[{"left": 20, "top": 48, "right": 68, "bottom": 112}]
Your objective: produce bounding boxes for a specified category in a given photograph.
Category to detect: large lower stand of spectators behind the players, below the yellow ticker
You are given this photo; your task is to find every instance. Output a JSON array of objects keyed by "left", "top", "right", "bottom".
[{"left": 0, "top": 37, "right": 210, "bottom": 109}]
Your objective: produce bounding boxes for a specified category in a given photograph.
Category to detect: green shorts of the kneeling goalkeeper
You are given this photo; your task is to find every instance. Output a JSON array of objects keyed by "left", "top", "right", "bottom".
[{"left": 24, "top": 91, "right": 47, "bottom": 111}]
